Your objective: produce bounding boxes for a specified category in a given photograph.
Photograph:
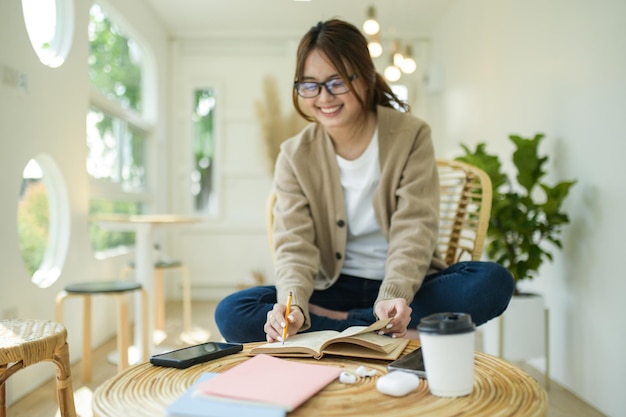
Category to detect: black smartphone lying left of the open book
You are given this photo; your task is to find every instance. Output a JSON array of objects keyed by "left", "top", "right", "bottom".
[{"left": 150, "top": 342, "right": 243, "bottom": 369}]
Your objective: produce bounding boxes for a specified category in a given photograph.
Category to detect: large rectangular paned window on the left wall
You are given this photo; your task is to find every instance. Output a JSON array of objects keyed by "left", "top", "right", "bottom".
[{"left": 86, "top": 4, "right": 152, "bottom": 257}]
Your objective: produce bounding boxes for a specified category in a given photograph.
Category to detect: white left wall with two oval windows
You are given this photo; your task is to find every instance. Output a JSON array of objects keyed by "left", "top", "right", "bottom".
[{"left": 0, "top": 0, "right": 95, "bottom": 401}]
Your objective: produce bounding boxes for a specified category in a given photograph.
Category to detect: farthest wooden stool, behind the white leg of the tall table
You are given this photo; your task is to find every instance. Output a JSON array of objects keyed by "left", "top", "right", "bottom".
[{"left": 122, "top": 261, "right": 191, "bottom": 333}]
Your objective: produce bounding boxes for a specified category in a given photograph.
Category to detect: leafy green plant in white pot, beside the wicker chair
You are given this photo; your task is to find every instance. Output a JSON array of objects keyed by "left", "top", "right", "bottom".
[{"left": 456, "top": 134, "right": 576, "bottom": 360}]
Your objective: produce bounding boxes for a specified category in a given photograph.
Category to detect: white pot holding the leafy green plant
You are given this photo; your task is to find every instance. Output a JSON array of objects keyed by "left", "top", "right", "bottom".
[{"left": 481, "top": 294, "right": 546, "bottom": 361}]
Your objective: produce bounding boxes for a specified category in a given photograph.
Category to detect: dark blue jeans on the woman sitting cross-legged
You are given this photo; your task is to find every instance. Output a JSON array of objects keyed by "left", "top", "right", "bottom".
[{"left": 215, "top": 262, "right": 515, "bottom": 343}]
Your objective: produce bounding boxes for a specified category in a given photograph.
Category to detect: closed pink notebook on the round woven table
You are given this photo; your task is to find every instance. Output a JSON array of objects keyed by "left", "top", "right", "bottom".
[{"left": 196, "top": 355, "right": 341, "bottom": 411}]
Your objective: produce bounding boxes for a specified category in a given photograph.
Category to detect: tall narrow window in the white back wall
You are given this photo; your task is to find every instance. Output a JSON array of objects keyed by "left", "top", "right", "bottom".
[{"left": 191, "top": 88, "right": 216, "bottom": 213}]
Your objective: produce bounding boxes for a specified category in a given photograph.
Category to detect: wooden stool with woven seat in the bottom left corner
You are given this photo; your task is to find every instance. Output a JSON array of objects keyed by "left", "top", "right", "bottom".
[{"left": 0, "top": 319, "right": 76, "bottom": 417}]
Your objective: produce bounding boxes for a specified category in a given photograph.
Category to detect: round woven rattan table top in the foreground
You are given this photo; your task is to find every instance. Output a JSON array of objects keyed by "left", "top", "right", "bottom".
[{"left": 93, "top": 341, "right": 547, "bottom": 417}]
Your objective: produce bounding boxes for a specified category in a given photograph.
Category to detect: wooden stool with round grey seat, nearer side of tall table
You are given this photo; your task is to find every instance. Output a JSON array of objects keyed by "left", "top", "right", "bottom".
[{"left": 56, "top": 280, "right": 149, "bottom": 382}]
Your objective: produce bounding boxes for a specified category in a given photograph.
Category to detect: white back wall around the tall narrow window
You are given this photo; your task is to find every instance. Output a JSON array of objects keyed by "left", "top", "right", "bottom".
[{"left": 170, "top": 35, "right": 428, "bottom": 300}]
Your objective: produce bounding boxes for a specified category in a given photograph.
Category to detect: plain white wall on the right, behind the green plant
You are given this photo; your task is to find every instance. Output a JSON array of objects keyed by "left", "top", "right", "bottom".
[{"left": 430, "top": 0, "right": 626, "bottom": 417}]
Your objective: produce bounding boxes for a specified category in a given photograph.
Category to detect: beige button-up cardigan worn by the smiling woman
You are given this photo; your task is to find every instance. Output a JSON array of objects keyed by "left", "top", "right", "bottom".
[{"left": 273, "top": 106, "right": 446, "bottom": 330}]
